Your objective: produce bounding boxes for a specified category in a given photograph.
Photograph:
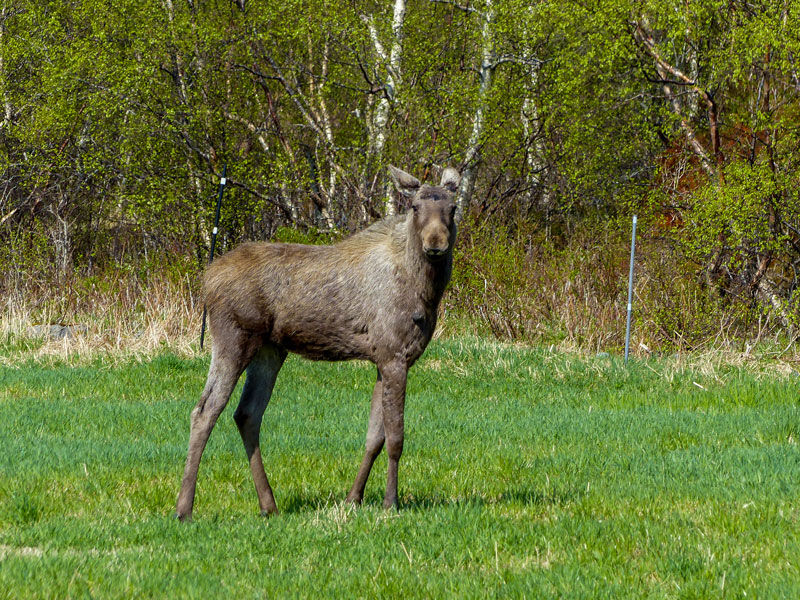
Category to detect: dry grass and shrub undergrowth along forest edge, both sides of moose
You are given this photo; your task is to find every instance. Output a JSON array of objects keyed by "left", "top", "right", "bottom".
[{"left": 0, "top": 221, "right": 800, "bottom": 364}]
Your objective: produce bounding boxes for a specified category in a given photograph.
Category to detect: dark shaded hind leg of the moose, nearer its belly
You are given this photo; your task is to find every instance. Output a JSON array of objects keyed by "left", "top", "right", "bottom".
[{"left": 233, "top": 345, "right": 286, "bottom": 516}]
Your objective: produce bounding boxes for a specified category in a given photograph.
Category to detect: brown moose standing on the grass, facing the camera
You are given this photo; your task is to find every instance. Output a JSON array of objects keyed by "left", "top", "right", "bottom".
[{"left": 177, "top": 166, "right": 460, "bottom": 520}]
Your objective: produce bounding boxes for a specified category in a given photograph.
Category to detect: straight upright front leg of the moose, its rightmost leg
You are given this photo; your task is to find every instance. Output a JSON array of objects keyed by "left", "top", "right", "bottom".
[{"left": 381, "top": 362, "right": 408, "bottom": 508}]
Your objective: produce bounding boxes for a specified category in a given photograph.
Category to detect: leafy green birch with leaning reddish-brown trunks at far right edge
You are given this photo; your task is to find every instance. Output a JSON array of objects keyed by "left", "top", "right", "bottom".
[{"left": 631, "top": 1, "right": 800, "bottom": 326}]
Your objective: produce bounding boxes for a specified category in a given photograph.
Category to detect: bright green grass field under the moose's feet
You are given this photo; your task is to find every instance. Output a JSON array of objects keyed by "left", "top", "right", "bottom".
[{"left": 0, "top": 339, "right": 800, "bottom": 598}]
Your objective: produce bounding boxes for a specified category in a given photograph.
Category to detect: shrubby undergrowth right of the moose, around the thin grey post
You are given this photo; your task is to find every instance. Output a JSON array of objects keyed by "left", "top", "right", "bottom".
[{"left": 444, "top": 222, "right": 798, "bottom": 361}]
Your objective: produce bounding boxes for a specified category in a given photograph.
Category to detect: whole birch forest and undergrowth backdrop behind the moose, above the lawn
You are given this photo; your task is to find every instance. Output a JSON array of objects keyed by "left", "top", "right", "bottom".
[{"left": 0, "top": 0, "right": 800, "bottom": 358}]
